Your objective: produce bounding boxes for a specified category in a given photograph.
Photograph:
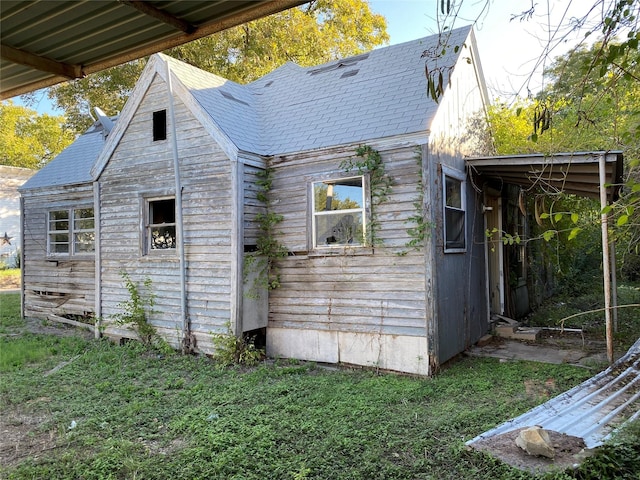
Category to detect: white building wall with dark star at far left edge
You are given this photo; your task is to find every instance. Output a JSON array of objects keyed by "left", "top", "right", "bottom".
[{"left": 0, "top": 165, "right": 36, "bottom": 267}]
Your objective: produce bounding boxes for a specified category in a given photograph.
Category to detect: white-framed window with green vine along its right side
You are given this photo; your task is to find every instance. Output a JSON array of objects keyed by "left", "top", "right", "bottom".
[{"left": 312, "top": 176, "right": 366, "bottom": 248}]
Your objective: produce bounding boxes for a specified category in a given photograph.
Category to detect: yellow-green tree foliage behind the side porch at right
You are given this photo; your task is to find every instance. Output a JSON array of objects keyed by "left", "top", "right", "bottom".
[{"left": 489, "top": 33, "right": 640, "bottom": 278}]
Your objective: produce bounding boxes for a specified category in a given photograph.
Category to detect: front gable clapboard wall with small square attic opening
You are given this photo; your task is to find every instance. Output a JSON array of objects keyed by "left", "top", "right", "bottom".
[{"left": 99, "top": 77, "right": 236, "bottom": 351}]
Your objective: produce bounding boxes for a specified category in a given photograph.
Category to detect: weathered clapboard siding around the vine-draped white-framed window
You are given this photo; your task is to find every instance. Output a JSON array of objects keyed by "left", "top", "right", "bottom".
[{"left": 269, "top": 141, "right": 427, "bottom": 336}]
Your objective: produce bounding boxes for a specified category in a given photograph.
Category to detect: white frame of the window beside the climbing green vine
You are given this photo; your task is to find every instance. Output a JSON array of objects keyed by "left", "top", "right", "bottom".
[{"left": 309, "top": 175, "right": 369, "bottom": 252}]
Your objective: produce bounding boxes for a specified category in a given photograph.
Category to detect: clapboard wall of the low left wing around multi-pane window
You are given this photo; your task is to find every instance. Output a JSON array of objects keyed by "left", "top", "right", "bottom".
[{"left": 23, "top": 185, "right": 95, "bottom": 323}]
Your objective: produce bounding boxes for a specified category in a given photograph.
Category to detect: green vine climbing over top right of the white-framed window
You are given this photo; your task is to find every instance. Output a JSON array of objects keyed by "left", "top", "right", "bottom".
[{"left": 340, "top": 145, "right": 393, "bottom": 246}]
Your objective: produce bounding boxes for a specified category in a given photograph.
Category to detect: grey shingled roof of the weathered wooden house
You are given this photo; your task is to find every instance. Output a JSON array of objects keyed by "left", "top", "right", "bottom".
[{"left": 21, "top": 27, "right": 472, "bottom": 191}]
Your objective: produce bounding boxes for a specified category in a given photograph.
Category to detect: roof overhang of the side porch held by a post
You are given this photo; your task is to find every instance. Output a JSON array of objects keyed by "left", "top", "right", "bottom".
[{"left": 466, "top": 151, "right": 623, "bottom": 200}]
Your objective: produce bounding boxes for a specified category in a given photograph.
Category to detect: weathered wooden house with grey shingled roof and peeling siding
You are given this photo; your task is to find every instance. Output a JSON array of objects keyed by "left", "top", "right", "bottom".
[{"left": 21, "top": 27, "right": 620, "bottom": 375}]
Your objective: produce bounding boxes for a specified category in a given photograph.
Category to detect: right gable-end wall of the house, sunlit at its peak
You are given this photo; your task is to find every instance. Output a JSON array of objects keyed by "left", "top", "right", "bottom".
[{"left": 427, "top": 35, "right": 489, "bottom": 363}]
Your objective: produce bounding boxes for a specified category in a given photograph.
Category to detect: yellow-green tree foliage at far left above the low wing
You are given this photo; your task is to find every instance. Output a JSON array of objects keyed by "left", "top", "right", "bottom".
[{"left": 0, "top": 101, "right": 74, "bottom": 169}]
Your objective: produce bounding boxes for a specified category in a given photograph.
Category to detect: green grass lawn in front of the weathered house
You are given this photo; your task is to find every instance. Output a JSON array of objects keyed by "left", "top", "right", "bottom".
[{"left": 0, "top": 294, "right": 640, "bottom": 480}]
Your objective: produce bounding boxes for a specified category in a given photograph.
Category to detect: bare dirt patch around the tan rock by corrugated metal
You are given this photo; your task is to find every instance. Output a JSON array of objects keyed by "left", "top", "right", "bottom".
[{"left": 471, "top": 428, "right": 590, "bottom": 474}]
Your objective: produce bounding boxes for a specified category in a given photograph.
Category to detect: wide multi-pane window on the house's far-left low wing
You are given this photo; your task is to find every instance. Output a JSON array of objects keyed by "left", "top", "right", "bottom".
[{"left": 47, "top": 208, "right": 95, "bottom": 255}]
